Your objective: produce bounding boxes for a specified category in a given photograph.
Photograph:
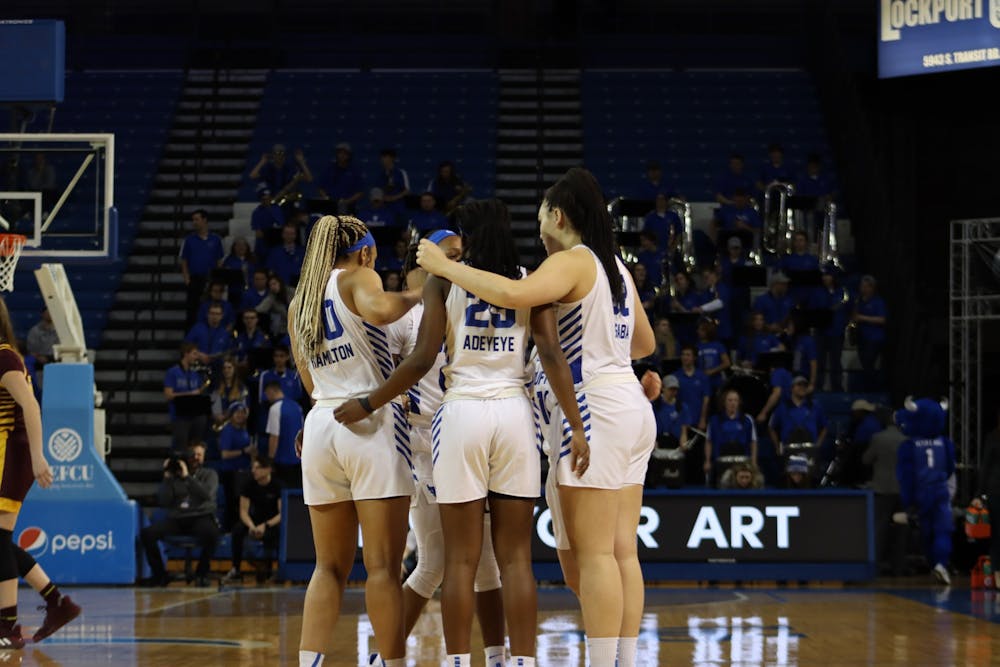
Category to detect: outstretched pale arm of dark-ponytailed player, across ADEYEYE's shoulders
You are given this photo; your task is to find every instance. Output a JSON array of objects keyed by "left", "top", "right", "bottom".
[{"left": 417, "top": 239, "right": 580, "bottom": 310}]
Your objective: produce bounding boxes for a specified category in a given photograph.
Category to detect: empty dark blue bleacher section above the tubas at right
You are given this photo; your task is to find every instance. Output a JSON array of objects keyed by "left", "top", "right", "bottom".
[{"left": 582, "top": 70, "right": 833, "bottom": 201}]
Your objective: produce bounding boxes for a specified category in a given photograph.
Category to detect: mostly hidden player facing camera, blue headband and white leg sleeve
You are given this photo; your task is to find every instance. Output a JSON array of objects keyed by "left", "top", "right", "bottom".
[{"left": 380, "top": 229, "right": 506, "bottom": 667}]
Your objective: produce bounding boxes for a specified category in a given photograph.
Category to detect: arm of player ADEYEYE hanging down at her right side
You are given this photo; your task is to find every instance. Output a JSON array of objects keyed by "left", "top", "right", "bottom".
[{"left": 531, "top": 304, "right": 588, "bottom": 476}]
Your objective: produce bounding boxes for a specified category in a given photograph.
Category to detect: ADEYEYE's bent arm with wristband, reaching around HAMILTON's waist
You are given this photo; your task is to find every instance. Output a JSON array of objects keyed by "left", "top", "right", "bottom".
[{"left": 333, "top": 276, "right": 451, "bottom": 424}]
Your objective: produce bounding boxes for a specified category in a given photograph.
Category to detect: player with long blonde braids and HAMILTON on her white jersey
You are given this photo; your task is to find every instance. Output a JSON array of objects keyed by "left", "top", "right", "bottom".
[{"left": 288, "top": 216, "right": 419, "bottom": 667}]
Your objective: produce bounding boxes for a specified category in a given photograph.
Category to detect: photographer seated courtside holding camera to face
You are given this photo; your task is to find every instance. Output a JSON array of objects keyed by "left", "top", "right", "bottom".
[{"left": 141, "top": 443, "right": 219, "bottom": 586}]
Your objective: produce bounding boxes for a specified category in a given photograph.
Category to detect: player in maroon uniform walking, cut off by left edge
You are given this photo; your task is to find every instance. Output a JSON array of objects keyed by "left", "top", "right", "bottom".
[{"left": 0, "top": 299, "right": 80, "bottom": 649}]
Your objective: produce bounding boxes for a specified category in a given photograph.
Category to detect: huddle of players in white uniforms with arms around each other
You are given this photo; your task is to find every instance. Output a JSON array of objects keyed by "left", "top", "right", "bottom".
[{"left": 289, "top": 169, "right": 655, "bottom": 667}]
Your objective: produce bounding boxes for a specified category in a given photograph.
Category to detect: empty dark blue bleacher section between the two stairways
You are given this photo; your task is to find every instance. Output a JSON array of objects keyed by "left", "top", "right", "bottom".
[{"left": 239, "top": 71, "right": 499, "bottom": 206}]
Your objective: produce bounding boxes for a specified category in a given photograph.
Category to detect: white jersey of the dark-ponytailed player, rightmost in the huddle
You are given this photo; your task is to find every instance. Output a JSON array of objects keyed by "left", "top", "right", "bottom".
[{"left": 556, "top": 245, "right": 635, "bottom": 387}]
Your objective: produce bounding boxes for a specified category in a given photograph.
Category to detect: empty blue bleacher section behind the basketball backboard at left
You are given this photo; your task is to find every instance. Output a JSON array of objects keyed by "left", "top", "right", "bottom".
[{"left": 7, "top": 71, "right": 183, "bottom": 348}]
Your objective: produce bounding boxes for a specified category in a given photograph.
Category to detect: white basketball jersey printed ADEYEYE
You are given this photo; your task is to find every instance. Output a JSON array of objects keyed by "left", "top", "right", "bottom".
[{"left": 443, "top": 285, "right": 530, "bottom": 399}]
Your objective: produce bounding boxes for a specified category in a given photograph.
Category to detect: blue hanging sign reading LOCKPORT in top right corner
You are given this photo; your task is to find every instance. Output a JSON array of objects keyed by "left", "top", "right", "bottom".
[{"left": 878, "top": 0, "right": 1000, "bottom": 79}]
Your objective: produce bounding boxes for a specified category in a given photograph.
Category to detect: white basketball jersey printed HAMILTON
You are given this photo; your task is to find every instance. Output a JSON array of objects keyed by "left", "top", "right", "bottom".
[{"left": 309, "top": 269, "right": 393, "bottom": 400}]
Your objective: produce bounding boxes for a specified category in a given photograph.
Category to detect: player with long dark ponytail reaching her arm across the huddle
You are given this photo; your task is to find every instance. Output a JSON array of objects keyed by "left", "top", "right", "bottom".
[{"left": 417, "top": 168, "right": 656, "bottom": 667}]
